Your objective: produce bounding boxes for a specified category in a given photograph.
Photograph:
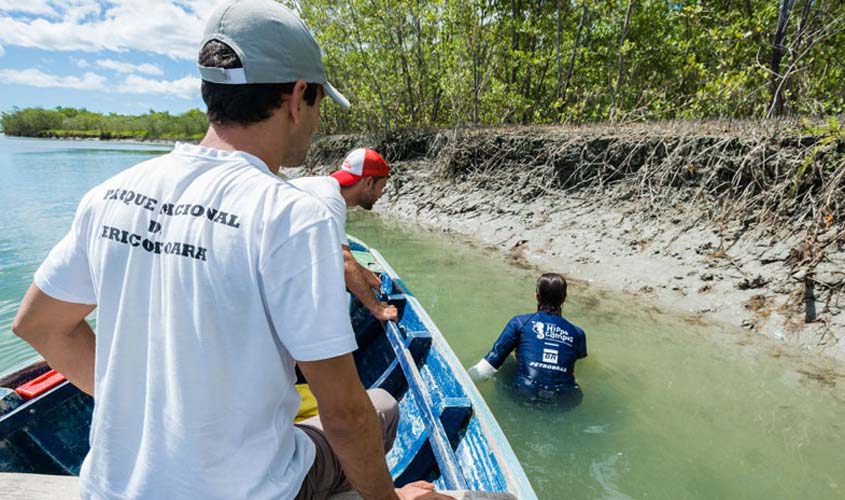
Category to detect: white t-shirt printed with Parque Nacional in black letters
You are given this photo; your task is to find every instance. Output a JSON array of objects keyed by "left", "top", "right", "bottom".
[{"left": 35, "top": 144, "right": 356, "bottom": 500}]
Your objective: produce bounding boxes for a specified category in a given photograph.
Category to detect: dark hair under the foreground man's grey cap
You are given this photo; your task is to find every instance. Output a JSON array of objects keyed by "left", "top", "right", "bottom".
[{"left": 198, "top": 40, "right": 320, "bottom": 125}]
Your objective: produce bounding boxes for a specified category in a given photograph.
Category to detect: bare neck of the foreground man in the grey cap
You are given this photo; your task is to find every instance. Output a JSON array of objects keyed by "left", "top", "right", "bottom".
[{"left": 200, "top": 123, "right": 285, "bottom": 174}]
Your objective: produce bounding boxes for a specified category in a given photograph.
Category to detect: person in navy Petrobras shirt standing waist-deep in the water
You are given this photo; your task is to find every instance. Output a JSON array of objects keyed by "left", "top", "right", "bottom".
[{"left": 469, "top": 273, "right": 587, "bottom": 403}]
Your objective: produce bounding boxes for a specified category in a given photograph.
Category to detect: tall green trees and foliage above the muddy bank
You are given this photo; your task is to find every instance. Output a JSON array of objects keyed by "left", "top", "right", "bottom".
[{"left": 286, "top": 0, "right": 845, "bottom": 133}]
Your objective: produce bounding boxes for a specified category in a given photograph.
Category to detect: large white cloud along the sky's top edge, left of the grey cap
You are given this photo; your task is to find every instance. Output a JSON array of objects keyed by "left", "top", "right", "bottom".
[{"left": 0, "top": 0, "right": 227, "bottom": 60}]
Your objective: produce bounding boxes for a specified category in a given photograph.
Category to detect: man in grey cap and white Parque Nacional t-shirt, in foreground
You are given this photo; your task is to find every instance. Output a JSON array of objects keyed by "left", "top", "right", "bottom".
[{"left": 13, "top": 0, "right": 446, "bottom": 500}]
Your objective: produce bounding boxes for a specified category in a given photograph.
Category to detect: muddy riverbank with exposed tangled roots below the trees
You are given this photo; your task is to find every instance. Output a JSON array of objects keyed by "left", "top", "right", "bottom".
[{"left": 289, "top": 124, "right": 845, "bottom": 363}]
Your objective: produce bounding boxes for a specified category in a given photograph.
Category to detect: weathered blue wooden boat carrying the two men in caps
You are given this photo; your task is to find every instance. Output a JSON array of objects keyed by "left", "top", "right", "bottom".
[{"left": 0, "top": 238, "right": 537, "bottom": 500}]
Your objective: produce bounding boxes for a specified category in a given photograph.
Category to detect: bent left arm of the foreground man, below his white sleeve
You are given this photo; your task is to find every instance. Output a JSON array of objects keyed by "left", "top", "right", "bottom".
[{"left": 12, "top": 283, "right": 96, "bottom": 396}]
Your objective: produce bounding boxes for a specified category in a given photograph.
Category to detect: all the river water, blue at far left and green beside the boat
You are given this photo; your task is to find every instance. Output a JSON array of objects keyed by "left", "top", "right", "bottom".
[{"left": 0, "top": 135, "right": 845, "bottom": 500}]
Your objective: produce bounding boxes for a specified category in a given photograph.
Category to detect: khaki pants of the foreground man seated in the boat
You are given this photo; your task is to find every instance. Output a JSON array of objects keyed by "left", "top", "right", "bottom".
[{"left": 296, "top": 389, "right": 399, "bottom": 500}]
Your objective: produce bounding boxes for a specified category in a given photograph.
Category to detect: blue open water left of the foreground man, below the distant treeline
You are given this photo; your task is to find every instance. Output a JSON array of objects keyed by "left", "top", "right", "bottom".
[{"left": 0, "top": 134, "right": 170, "bottom": 373}]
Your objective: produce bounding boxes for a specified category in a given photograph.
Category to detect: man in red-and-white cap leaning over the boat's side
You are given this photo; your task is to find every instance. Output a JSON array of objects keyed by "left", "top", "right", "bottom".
[{"left": 290, "top": 148, "right": 398, "bottom": 321}]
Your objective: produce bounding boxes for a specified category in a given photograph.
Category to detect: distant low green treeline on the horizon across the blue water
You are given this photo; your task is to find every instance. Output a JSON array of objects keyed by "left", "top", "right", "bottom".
[{"left": 0, "top": 108, "right": 208, "bottom": 140}]
